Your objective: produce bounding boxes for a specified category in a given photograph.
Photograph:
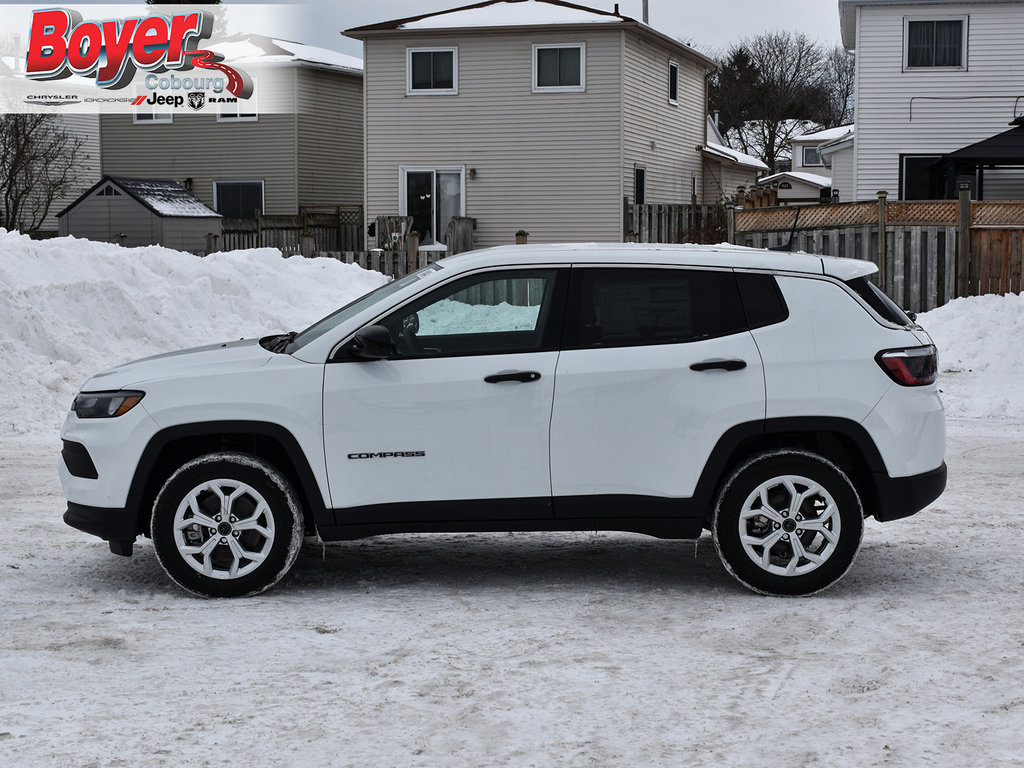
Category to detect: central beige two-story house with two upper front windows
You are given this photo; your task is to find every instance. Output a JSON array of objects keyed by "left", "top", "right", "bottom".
[{"left": 345, "top": 0, "right": 714, "bottom": 247}]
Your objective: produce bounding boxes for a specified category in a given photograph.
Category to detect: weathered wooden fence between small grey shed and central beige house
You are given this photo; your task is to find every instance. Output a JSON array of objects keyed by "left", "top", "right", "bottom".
[{"left": 217, "top": 206, "right": 366, "bottom": 256}]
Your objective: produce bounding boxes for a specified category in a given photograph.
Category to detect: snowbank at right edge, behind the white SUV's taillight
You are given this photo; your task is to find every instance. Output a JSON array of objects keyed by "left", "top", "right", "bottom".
[{"left": 918, "top": 293, "right": 1024, "bottom": 419}]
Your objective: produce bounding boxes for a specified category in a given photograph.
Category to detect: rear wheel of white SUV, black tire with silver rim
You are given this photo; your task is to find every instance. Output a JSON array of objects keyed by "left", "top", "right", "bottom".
[{"left": 712, "top": 450, "right": 864, "bottom": 595}]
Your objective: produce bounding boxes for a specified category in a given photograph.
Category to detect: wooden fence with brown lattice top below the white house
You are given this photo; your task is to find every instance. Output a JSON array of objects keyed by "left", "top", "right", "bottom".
[{"left": 729, "top": 197, "right": 1024, "bottom": 312}]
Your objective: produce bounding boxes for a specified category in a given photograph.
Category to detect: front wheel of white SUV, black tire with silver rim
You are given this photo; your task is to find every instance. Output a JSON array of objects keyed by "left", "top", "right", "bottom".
[{"left": 151, "top": 453, "right": 304, "bottom": 597}]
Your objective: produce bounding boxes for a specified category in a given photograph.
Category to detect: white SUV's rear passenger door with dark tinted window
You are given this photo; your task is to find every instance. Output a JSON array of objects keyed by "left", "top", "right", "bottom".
[{"left": 551, "top": 266, "right": 765, "bottom": 517}]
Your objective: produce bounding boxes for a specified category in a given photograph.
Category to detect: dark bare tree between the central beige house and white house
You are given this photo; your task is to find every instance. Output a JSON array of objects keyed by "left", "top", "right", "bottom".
[{"left": 710, "top": 31, "right": 828, "bottom": 169}]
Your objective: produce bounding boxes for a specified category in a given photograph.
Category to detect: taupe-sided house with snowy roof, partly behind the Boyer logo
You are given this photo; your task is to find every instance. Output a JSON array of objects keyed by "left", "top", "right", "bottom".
[{"left": 100, "top": 36, "right": 362, "bottom": 217}]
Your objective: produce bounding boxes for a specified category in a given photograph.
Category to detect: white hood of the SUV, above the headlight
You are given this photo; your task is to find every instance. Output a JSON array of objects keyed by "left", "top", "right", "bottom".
[{"left": 82, "top": 339, "right": 273, "bottom": 392}]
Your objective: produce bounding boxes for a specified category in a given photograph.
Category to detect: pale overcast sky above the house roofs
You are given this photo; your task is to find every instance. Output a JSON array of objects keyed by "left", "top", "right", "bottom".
[{"left": 0, "top": 0, "right": 840, "bottom": 55}]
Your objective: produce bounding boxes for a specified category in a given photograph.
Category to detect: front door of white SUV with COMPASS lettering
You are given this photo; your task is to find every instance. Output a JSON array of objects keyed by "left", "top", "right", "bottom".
[{"left": 324, "top": 268, "right": 566, "bottom": 524}]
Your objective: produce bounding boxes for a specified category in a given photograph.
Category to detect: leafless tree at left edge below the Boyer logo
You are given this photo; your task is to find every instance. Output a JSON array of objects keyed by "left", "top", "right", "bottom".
[{"left": 0, "top": 114, "right": 82, "bottom": 233}]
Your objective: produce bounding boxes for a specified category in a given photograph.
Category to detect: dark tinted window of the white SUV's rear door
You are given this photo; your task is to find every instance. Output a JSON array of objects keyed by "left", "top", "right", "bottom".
[{"left": 563, "top": 267, "right": 745, "bottom": 347}]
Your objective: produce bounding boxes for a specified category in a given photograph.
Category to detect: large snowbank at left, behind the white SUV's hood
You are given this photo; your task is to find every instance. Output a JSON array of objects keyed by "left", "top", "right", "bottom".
[{"left": 0, "top": 229, "right": 387, "bottom": 436}]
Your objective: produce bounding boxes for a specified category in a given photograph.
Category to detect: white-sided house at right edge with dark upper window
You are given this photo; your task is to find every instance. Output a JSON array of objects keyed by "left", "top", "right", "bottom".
[{"left": 839, "top": 0, "right": 1024, "bottom": 200}]
